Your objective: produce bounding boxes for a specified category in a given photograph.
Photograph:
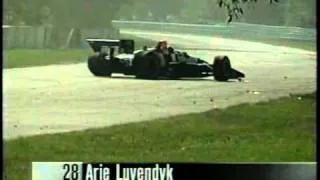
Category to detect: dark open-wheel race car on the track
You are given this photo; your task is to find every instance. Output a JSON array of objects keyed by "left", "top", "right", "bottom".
[{"left": 87, "top": 39, "right": 245, "bottom": 81}]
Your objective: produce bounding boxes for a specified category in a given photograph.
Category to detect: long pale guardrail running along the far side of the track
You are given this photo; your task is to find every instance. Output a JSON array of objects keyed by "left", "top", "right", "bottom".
[{"left": 112, "top": 20, "right": 316, "bottom": 41}]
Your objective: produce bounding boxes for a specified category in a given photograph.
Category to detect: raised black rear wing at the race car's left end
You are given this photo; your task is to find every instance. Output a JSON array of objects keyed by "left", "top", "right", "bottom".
[{"left": 86, "top": 39, "right": 134, "bottom": 54}]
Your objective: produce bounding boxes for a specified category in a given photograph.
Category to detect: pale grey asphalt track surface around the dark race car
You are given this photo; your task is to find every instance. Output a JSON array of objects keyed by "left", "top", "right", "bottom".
[{"left": 3, "top": 31, "right": 316, "bottom": 139}]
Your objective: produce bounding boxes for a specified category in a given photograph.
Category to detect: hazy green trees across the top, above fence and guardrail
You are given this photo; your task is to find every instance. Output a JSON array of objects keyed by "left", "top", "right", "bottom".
[{"left": 4, "top": 0, "right": 316, "bottom": 28}]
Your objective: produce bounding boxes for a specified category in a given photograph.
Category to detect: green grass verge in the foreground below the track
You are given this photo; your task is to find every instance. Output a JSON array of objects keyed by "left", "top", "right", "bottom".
[{"left": 4, "top": 93, "right": 316, "bottom": 180}]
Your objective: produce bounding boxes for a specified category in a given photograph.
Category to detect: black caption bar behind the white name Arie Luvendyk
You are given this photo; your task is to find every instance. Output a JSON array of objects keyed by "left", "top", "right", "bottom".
[{"left": 82, "top": 163, "right": 317, "bottom": 180}]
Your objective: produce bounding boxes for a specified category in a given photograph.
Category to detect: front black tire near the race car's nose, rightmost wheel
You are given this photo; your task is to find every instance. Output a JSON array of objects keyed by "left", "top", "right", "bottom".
[{"left": 213, "top": 56, "right": 231, "bottom": 81}]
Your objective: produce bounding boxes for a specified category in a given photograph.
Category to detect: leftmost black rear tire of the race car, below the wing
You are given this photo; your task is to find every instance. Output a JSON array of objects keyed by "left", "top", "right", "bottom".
[{"left": 88, "top": 55, "right": 112, "bottom": 77}]
